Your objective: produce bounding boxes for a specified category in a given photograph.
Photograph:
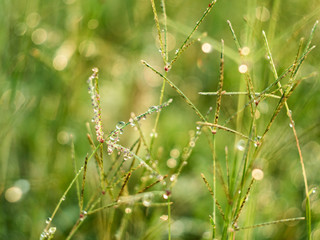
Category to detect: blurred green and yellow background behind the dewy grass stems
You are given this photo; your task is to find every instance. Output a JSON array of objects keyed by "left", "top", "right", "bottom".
[{"left": 0, "top": 0, "right": 320, "bottom": 239}]
